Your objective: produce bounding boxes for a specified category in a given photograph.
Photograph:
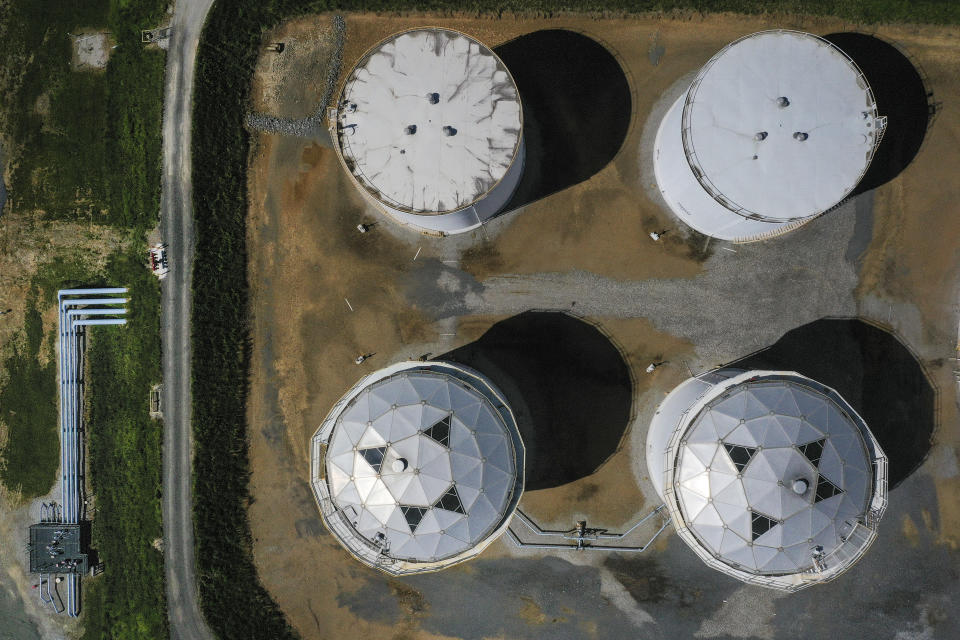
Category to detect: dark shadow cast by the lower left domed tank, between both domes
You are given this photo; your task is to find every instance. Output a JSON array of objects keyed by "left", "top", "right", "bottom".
[{"left": 437, "top": 311, "right": 633, "bottom": 491}]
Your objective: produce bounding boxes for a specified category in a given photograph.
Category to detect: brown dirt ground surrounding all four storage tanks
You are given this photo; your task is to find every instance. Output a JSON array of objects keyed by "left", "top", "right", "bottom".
[{"left": 249, "top": 15, "right": 960, "bottom": 638}]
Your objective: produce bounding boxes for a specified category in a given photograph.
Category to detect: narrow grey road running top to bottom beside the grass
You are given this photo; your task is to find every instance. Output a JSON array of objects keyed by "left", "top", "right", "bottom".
[{"left": 160, "top": 0, "right": 213, "bottom": 640}]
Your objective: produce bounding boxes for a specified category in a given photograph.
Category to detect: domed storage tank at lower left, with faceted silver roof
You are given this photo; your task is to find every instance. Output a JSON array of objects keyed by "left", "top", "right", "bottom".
[{"left": 311, "top": 362, "right": 524, "bottom": 575}]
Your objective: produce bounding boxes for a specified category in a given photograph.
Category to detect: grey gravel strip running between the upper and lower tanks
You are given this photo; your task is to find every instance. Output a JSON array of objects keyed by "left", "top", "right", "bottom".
[{"left": 409, "top": 194, "right": 870, "bottom": 368}]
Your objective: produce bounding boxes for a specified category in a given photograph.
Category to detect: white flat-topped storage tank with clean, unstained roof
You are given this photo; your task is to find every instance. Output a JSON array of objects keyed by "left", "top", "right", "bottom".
[{"left": 654, "top": 30, "right": 886, "bottom": 242}]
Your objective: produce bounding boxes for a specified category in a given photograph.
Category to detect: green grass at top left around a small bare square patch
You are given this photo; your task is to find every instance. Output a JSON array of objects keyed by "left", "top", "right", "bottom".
[{"left": 0, "top": 0, "right": 166, "bottom": 227}]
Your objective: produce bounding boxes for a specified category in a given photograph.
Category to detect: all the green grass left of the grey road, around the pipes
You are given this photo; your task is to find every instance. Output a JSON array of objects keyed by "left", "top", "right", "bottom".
[{"left": 0, "top": 0, "right": 168, "bottom": 640}]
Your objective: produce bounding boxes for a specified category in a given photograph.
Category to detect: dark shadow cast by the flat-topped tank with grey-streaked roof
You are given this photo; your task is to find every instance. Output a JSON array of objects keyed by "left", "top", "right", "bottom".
[{"left": 494, "top": 29, "right": 632, "bottom": 212}]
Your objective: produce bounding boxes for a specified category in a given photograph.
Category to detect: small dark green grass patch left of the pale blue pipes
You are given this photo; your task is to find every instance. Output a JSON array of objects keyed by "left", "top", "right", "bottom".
[{"left": 0, "top": 292, "right": 60, "bottom": 498}]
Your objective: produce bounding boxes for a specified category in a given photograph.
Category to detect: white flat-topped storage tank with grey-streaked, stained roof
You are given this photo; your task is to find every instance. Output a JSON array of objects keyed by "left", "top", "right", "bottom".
[{"left": 331, "top": 27, "right": 524, "bottom": 233}]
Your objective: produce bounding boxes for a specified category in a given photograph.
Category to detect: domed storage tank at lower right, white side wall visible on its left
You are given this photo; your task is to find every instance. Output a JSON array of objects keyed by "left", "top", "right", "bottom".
[{"left": 647, "top": 369, "right": 887, "bottom": 591}]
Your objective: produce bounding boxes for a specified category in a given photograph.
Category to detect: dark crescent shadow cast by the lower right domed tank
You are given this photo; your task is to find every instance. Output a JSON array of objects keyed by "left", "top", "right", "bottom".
[{"left": 727, "top": 318, "right": 937, "bottom": 489}]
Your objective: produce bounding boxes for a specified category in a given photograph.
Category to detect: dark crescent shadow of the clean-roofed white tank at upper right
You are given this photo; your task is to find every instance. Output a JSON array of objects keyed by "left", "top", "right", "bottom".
[{"left": 824, "top": 32, "right": 936, "bottom": 196}]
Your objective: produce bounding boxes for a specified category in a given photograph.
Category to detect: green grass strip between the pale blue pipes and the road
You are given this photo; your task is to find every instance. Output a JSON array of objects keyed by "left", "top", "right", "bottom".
[{"left": 84, "top": 245, "right": 167, "bottom": 640}]
